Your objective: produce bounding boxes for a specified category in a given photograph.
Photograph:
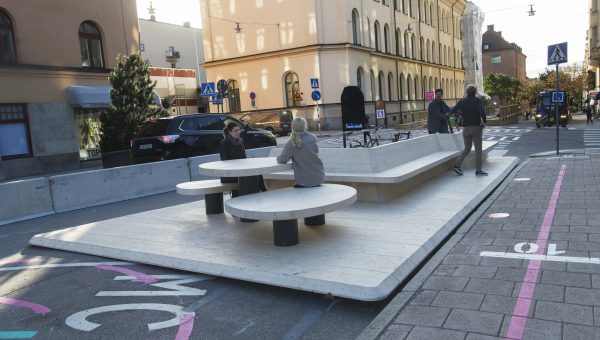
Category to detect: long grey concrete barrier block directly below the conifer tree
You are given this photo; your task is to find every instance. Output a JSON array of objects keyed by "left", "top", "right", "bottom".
[{"left": 50, "top": 158, "right": 190, "bottom": 212}]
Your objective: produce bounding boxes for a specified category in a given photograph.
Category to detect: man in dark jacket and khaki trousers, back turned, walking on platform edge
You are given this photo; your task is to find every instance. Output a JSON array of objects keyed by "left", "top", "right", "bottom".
[{"left": 450, "top": 85, "right": 487, "bottom": 176}]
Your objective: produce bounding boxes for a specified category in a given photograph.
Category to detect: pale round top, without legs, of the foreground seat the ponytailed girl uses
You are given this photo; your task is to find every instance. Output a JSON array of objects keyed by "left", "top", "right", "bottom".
[{"left": 225, "top": 184, "right": 356, "bottom": 221}]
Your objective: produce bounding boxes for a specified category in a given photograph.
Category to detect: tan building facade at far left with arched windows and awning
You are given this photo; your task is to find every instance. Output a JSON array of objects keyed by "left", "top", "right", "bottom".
[{"left": 0, "top": 0, "right": 139, "bottom": 179}]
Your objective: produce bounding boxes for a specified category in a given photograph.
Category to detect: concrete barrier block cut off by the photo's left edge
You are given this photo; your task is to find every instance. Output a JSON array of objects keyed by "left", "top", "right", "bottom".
[{"left": 0, "top": 178, "right": 54, "bottom": 225}]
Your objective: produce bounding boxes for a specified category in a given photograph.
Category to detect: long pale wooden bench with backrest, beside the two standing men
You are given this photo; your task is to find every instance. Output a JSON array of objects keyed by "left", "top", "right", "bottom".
[{"left": 264, "top": 133, "right": 494, "bottom": 202}]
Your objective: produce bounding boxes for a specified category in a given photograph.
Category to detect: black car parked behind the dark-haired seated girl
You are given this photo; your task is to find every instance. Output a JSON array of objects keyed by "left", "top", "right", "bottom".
[{"left": 131, "top": 113, "right": 277, "bottom": 163}]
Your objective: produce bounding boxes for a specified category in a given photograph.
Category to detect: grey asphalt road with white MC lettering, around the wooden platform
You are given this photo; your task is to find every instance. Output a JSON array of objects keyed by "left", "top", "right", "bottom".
[{"left": 0, "top": 115, "right": 586, "bottom": 339}]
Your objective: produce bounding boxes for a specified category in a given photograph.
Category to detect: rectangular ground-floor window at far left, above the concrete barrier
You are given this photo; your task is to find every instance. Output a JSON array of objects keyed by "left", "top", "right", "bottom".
[{"left": 0, "top": 104, "right": 31, "bottom": 160}]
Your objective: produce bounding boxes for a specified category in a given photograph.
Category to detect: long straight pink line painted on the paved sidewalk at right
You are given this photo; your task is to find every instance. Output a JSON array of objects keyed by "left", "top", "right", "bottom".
[{"left": 506, "top": 164, "right": 567, "bottom": 340}]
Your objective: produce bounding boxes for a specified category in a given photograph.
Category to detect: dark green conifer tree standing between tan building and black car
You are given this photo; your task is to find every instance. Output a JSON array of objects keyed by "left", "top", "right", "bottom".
[{"left": 100, "top": 52, "right": 166, "bottom": 168}]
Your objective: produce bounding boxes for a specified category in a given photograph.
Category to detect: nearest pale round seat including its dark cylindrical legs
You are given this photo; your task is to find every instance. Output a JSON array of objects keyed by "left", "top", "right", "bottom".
[{"left": 225, "top": 184, "right": 357, "bottom": 246}]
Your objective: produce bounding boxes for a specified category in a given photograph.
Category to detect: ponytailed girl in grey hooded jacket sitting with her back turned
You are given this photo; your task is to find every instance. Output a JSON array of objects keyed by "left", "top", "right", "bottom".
[{"left": 277, "top": 117, "right": 325, "bottom": 188}]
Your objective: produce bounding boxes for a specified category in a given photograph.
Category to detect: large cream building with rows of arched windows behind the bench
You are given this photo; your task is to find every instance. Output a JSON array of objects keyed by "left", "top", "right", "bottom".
[{"left": 201, "top": 0, "right": 466, "bottom": 129}]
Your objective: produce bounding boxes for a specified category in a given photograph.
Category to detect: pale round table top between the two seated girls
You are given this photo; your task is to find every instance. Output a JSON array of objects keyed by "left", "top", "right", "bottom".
[{"left": 199, "top": 157, "right": 292, "bottom": 177}]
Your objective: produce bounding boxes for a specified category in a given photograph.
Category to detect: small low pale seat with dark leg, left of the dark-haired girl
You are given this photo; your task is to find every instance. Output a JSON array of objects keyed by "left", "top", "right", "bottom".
[{"left": 176, "top": 179, "right": 239, "bottom": 214}]
